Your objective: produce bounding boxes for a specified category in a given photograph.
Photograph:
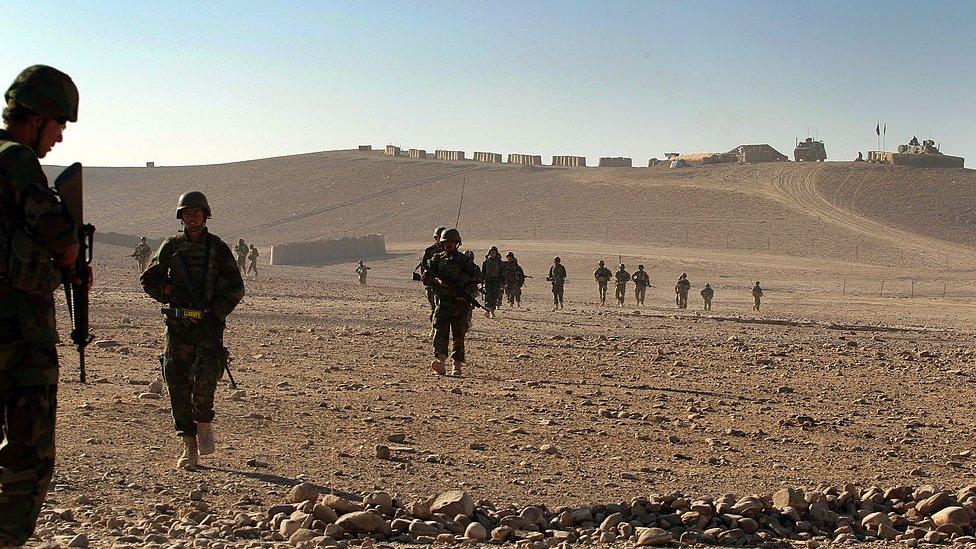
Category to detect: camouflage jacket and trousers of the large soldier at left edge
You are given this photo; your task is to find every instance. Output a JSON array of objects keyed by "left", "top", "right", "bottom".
[{"left": 0, "top": 130, "right": 78, "bottom": 546}]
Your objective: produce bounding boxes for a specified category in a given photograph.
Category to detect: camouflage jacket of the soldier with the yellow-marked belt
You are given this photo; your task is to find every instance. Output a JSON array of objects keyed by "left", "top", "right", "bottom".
[{"left": 140, "top": 231, "right": 244, "bottom": 321}]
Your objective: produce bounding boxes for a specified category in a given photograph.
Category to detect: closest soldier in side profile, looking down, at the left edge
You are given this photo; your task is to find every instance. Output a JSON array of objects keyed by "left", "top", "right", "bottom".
[{"left": 0, "top": 65, "right": 79, "bottom": 547}]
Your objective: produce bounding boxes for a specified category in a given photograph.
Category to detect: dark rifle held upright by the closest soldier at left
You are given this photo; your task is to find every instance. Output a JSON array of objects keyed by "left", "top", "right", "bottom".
[{"left": 54, "top": 162, "right": 95, "bottom": 383}]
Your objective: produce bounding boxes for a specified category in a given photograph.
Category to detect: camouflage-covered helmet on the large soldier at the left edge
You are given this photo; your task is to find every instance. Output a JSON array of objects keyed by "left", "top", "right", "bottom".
[{"left": 3, "top": 65, "right": 78, "bottom": 123}]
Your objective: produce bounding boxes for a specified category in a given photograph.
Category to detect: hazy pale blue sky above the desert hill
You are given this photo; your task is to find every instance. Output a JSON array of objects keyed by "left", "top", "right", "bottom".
[{"left": 0, "top": 0, "right": 976, "bottom": 166}]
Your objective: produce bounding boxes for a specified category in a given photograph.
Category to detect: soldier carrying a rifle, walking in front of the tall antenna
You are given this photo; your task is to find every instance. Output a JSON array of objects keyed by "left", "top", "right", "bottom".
[{"left": 421, "top": 229, "right": 481, "bottom": 376}]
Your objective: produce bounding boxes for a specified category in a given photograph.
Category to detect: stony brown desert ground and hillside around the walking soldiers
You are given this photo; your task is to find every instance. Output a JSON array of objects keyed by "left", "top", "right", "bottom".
[{"left": 26, "top": 151, "right": 976, "bottom": 548}]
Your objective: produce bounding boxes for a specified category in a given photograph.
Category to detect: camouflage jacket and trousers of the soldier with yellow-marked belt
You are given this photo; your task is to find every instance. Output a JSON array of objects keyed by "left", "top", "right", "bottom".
[{"left": 141, "top": 230, "right": 244, "bottom": 437}]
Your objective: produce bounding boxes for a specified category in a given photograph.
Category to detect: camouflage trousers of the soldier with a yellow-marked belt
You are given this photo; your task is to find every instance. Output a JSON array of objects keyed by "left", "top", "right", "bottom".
[{"left": 163, "top": 324, "right": 226, "bottom": 437}]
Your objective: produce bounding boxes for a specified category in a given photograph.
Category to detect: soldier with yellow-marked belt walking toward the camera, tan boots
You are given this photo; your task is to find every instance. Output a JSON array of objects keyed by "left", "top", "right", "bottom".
[{"left": 141, "top": 191, "right": 244, "bottom": 471}]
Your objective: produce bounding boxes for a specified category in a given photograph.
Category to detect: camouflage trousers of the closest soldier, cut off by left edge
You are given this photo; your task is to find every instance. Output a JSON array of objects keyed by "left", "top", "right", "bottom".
[{"left": 0, "top": 297, "right": 58, "bottom": 546}]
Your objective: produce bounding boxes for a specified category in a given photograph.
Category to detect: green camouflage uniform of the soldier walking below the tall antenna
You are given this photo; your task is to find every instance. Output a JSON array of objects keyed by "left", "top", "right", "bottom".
[{"left": 427, "top": 251, "right": 481, "bottom": 362}]
